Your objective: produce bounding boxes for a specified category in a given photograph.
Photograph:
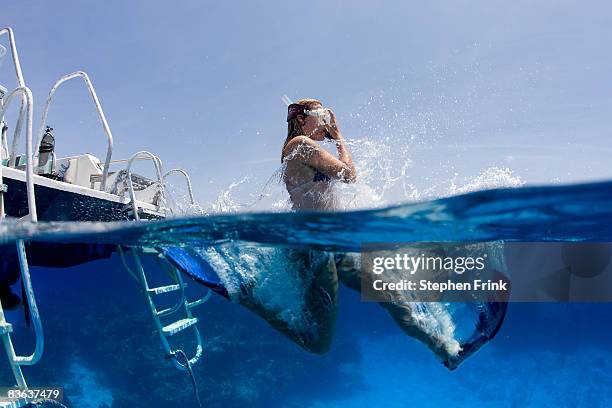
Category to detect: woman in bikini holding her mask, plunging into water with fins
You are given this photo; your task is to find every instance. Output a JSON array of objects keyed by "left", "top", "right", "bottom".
[{"left": 169, "top": 99, "right": 507, "bottom": 369}]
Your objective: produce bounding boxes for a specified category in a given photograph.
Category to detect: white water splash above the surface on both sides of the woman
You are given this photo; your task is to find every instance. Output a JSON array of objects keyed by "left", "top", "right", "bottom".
[{"left": 209, "top": 140, "right": 525, "bottom": 213}]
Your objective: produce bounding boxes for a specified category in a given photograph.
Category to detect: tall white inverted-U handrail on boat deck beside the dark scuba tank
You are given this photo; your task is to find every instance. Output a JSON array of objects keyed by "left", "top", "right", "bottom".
[{"left": 36, "top": 71, "right": 113, "bottom": 191}]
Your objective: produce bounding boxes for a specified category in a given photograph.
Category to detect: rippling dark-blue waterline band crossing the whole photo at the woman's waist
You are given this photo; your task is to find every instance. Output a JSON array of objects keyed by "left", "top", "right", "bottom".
[{"left": 0, "top": 181, "right": 612, "bottom": 245}]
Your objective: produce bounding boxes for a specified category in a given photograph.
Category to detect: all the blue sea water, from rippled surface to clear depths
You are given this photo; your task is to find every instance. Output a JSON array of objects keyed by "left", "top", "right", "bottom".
[{"left": 0, "top": 182, "right": 612, "bottom": 407}]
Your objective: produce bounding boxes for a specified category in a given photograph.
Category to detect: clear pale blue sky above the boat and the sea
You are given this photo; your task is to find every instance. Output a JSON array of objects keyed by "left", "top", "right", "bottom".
[{"left": 0, "top": 0, "right": 612, "bottom": 207}]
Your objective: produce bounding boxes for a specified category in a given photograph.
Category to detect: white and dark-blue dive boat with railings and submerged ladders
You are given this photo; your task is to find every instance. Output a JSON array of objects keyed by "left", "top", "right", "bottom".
[{"left": 0, "top": 27, "right": 211, "bottom": 408}]
